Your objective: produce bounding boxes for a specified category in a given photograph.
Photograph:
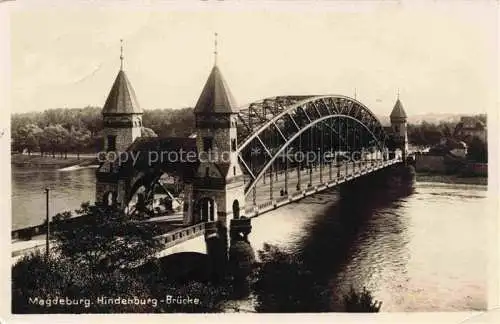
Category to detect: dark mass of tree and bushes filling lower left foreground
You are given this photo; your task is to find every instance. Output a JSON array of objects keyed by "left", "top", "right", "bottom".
[{"left": 12, "top": 203, "right": 230, "bottom": 313}]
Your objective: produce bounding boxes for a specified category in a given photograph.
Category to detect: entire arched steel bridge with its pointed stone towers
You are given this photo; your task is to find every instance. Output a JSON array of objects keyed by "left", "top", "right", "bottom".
[{"left": 10, "top": 49, "right": 408, "bottom": 274}]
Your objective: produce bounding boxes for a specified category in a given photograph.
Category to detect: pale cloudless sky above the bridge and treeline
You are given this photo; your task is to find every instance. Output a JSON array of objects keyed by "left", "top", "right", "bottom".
[{"left": 10, "top": 1, "right": 498, "bottom": 115}]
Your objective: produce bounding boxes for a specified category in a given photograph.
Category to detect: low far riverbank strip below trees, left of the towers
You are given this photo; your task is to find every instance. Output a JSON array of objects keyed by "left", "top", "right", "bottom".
[{"left": 11, "top": 154, "right": 97, "bottom": 169}]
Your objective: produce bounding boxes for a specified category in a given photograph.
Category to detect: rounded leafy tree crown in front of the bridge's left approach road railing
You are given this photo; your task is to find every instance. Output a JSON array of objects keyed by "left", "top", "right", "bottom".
[{"left": 53, "top": 203, "right": 163, "bottom": 269}]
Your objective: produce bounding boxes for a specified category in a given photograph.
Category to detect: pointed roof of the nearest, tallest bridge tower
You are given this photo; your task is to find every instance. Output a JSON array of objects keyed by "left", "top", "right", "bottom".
[{"left": 194, "top": 65, "right": 237, "bottom": 114}]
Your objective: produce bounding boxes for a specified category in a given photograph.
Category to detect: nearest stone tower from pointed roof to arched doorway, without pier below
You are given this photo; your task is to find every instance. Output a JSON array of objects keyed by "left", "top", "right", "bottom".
[{"left": 192, "top": 65, "right": 245, "bottom": 224}]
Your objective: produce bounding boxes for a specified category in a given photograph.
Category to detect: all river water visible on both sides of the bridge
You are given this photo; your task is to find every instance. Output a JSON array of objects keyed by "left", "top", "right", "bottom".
[{"left": 12, "top": 167, "right": 493, "bottom": 312}]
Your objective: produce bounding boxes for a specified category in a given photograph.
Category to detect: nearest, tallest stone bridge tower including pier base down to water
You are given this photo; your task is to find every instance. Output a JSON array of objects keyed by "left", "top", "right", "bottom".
[{"left": 185, "top": 44, "right": 251, "bottom": 278}]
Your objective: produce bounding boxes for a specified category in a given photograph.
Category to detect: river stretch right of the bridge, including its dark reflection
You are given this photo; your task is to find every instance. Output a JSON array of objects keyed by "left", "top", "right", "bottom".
[{"left": 250, "top": 167, "right": 491, "bottom": 311}]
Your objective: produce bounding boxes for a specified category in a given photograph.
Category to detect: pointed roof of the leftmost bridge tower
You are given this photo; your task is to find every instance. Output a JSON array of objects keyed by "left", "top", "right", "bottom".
[{"left": 102, "top": 70, "right": 143, "bottom": 115}]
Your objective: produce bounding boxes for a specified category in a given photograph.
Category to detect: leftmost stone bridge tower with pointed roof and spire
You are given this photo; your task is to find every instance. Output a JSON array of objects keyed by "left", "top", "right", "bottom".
[{"left": 96, "top": 42, "right": 143, "bottom": 207}]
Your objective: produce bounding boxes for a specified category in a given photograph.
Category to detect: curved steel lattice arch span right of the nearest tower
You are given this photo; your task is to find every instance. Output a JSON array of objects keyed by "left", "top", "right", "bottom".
[{"left": 238, "top": 95, "right": 388, "bottom": 194}]
